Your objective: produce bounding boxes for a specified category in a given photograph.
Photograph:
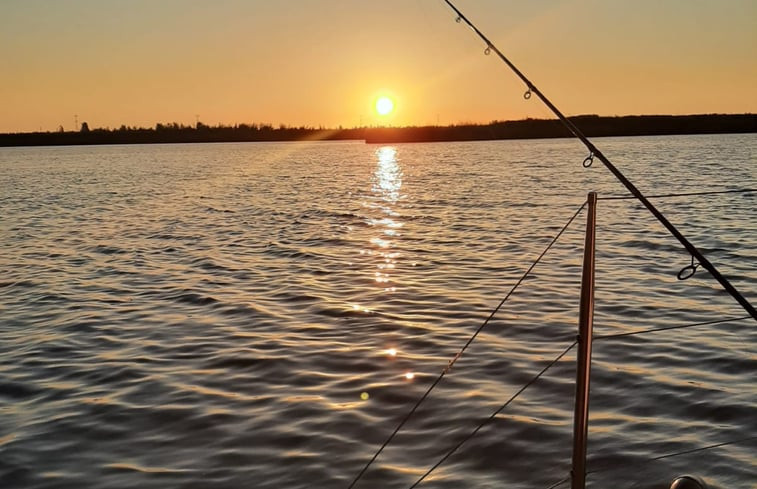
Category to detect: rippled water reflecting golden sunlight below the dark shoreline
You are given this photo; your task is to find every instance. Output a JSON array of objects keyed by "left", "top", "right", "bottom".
[{"left": 0, "top": 135, "right": 757, "bottom": 488}]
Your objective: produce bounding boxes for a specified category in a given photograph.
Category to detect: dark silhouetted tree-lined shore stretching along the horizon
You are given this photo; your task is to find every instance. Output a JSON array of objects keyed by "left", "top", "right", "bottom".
[{"left": 0, "top": 114, "right": 757, "bottom": 146}]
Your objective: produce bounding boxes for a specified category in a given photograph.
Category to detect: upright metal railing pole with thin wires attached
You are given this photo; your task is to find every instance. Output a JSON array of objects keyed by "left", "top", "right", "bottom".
[{"left": 570, "top": 192, "right": 597, "bottom": 489}]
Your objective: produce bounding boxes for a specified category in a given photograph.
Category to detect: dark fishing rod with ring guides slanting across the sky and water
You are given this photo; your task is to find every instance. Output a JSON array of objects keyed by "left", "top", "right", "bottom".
[{"left": 444, "top": 0, "right": 757, "bottom": 321}]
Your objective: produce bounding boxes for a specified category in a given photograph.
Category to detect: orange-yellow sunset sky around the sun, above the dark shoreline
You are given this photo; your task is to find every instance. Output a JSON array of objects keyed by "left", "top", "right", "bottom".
[{"left": 0, "top": 0, "right": 757, "bottom": 132}]
